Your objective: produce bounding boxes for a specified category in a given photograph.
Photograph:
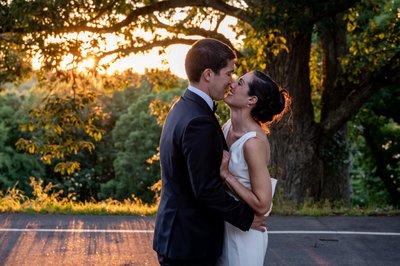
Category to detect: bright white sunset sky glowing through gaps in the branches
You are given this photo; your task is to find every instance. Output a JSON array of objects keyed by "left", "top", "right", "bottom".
[{"left": 32, "top": 17, "right": 241, "bottom": 78}]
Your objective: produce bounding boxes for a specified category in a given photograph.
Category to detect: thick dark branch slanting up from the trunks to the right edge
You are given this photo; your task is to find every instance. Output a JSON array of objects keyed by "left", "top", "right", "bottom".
[{"left": 321, "top": 52, "right": 400, "bottom": 138}]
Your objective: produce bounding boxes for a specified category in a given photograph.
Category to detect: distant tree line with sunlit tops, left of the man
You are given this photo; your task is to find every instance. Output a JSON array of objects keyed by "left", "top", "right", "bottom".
[{"left": 0, "top": 71, "right": 185, "bottom": 202}]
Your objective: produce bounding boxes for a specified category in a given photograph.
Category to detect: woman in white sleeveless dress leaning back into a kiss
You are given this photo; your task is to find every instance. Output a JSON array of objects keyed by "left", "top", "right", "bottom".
[{"left": 218, "top": 71, "right": 289, "bottom": 266}]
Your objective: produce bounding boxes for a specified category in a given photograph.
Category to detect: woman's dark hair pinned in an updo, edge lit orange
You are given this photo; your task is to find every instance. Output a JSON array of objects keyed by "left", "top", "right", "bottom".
[{"left": 248, "top": 70, "right": 290, "bottom": 128}]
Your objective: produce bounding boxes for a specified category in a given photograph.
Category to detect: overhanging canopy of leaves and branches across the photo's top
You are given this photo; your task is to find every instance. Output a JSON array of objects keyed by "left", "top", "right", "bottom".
[{"left": 0, "top": 0, "right": 400, "bottom": 133}]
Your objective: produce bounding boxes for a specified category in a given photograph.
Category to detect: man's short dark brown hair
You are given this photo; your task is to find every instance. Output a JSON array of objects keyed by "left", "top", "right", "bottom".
[{"left": 185, "top": 38, "right": 236, "bottom": 82}]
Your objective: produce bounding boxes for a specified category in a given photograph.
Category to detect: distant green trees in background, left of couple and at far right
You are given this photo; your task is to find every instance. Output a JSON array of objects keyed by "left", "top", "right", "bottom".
[{"left": 0, "top": 68, "right": 400, "bottom": 205}]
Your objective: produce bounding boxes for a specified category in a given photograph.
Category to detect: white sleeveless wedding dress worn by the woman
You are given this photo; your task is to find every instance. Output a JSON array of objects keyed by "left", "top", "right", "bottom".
[{"left": 217, "top": 120, "right": 276, "bottom": 266}]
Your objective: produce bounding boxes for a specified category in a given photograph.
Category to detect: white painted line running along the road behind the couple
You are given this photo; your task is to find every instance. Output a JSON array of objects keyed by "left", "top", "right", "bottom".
[{"left": 0, "top": 228, "right": 400, "bottom": 236}]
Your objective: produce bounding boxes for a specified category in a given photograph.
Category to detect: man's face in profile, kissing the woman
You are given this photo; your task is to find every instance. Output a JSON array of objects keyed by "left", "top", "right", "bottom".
[{"left": 210, "top": 59, "right": 235, "bottom": 101}]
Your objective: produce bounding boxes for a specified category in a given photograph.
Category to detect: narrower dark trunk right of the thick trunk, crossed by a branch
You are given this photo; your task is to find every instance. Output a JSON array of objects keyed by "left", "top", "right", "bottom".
[{"left": 318, "top": 15, "right": 351, "bottom": 202}]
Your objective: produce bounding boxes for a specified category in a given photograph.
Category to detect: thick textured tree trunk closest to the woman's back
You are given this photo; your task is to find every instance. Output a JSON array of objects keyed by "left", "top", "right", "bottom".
[{"left": 267, "top": 30, "right": 323, "bottom": 202}]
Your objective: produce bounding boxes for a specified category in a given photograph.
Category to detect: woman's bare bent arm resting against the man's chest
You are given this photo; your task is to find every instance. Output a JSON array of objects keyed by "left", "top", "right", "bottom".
[{"left": 221, "top": 138, "right": 272, "bottom": 215}]
